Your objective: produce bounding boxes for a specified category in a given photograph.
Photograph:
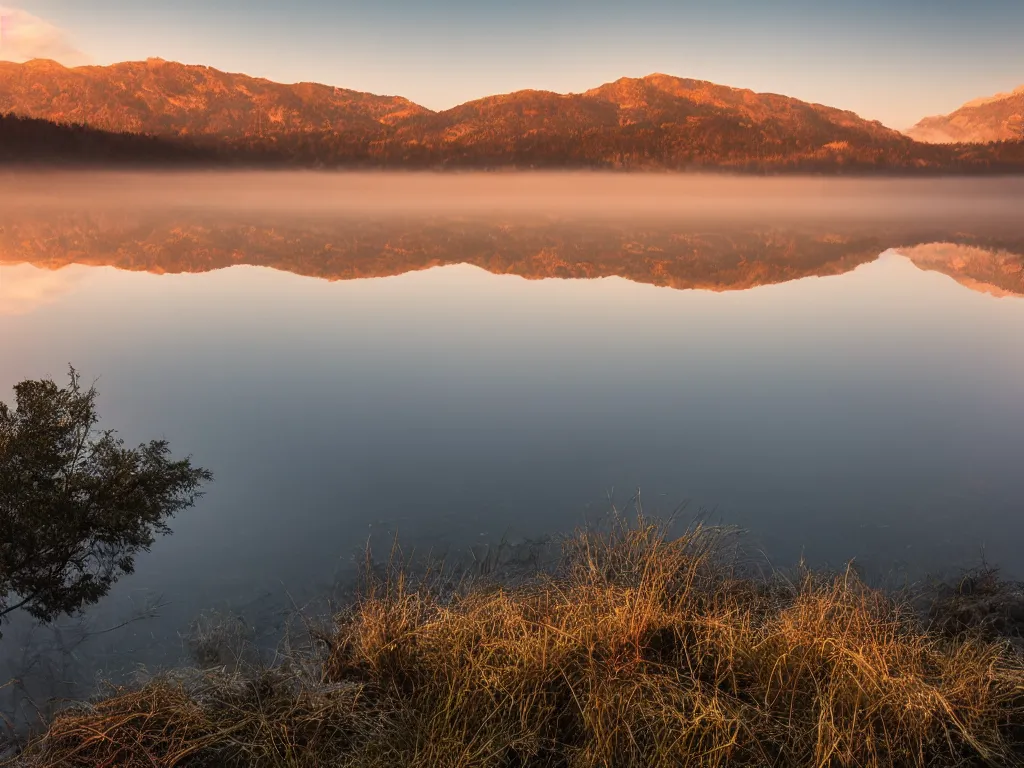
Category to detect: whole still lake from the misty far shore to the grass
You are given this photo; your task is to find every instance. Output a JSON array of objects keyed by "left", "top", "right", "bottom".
[{"left": 0, "top": 174, "right": 1024, "bottom": 692}]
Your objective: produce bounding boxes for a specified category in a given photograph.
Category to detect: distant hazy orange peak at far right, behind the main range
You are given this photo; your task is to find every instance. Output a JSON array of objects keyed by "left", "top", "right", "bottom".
[{"left": 906, "top": 85, "right": 1024, "bottom": 143}]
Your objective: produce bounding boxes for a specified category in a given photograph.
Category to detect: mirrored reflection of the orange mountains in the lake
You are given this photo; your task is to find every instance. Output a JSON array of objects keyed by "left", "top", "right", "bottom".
[{"left": 0, "top": 213, "right": 1024, "bottom": 295}]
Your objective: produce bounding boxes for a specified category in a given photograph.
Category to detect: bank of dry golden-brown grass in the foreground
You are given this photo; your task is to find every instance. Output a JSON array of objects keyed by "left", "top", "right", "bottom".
[{"left": 12, "top": 519, "right": 1024, "bottom": 768}]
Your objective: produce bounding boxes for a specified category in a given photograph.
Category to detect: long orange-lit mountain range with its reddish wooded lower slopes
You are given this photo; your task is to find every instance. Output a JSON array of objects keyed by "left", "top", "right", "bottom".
[{"left": 0, "top": 58, "right": 1024, "bottom": 172}]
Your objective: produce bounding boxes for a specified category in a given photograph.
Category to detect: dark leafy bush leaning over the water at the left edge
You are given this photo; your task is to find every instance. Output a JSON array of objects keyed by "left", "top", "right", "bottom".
[{"left": 0, "top": 369, "right": 212, "bottom": 622}]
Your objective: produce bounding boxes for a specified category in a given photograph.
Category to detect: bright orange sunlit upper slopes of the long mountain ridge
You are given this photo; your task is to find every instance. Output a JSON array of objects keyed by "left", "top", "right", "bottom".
[{"left": 0, "top": 58, "right": 899, "bottom": 143}]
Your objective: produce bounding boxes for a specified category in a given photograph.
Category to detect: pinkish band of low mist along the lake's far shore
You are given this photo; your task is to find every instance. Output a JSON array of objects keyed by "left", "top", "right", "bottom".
[{"left": 6, "top": 171, "right": 1024, "bottom": 220}]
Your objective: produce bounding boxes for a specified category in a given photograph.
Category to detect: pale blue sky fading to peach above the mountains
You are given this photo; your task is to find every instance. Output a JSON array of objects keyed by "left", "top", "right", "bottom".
[{"left": 0, "top": 0, "right": 1024, "bottom": 128}]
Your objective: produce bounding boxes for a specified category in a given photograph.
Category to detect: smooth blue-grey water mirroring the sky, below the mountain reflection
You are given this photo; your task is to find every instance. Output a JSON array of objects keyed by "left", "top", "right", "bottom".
[{"left": 0, "top": 174, "right": 1024, "bottom": 684}]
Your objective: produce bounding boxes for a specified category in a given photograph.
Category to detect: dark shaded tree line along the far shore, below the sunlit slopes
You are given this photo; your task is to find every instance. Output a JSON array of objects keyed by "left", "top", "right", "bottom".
[{"left": 0, "top": 114, "right": 1024, "bottom": 173}]
